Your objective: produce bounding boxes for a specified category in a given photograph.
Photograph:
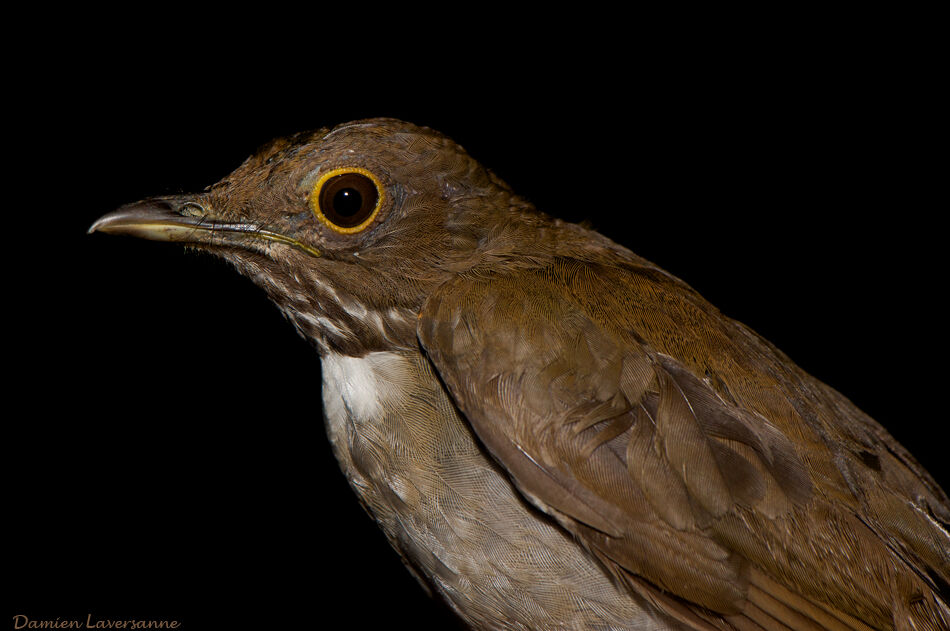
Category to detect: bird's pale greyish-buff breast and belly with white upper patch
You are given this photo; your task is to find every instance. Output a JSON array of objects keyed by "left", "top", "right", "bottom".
[{"left": 323, "top": 352, "right": 670, "bottom": 630}]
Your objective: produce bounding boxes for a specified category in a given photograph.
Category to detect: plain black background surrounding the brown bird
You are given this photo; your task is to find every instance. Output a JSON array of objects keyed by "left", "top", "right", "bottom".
[{"left": 0, "top": 16, "right": 950, "bottom": 629}]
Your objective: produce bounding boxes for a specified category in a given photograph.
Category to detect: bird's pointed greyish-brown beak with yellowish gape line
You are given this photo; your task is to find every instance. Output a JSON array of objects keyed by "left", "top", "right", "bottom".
[{"left": 88, "top": 197, "right": 320, "bottom": 256}]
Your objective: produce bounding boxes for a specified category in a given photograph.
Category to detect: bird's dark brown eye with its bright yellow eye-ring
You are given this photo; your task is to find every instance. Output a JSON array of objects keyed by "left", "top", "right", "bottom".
[{"left": 310, "top": 167, "right": 385, "bottom": 234}]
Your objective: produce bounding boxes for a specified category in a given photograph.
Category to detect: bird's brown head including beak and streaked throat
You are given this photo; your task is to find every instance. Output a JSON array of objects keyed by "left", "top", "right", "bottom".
[{"left": 89, "top": 119, "right": 547, "bottom": 355}]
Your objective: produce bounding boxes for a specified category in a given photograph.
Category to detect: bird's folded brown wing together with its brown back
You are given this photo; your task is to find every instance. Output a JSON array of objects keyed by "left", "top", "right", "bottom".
[{"left": 418, "top": 259, "right": 950, "bottom": 630}]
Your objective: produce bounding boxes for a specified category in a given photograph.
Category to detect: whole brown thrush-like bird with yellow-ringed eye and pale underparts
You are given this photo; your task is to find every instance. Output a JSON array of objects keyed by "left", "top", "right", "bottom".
[{"left": 89, "top": 118, "right": 950, "bottom": 631}]
